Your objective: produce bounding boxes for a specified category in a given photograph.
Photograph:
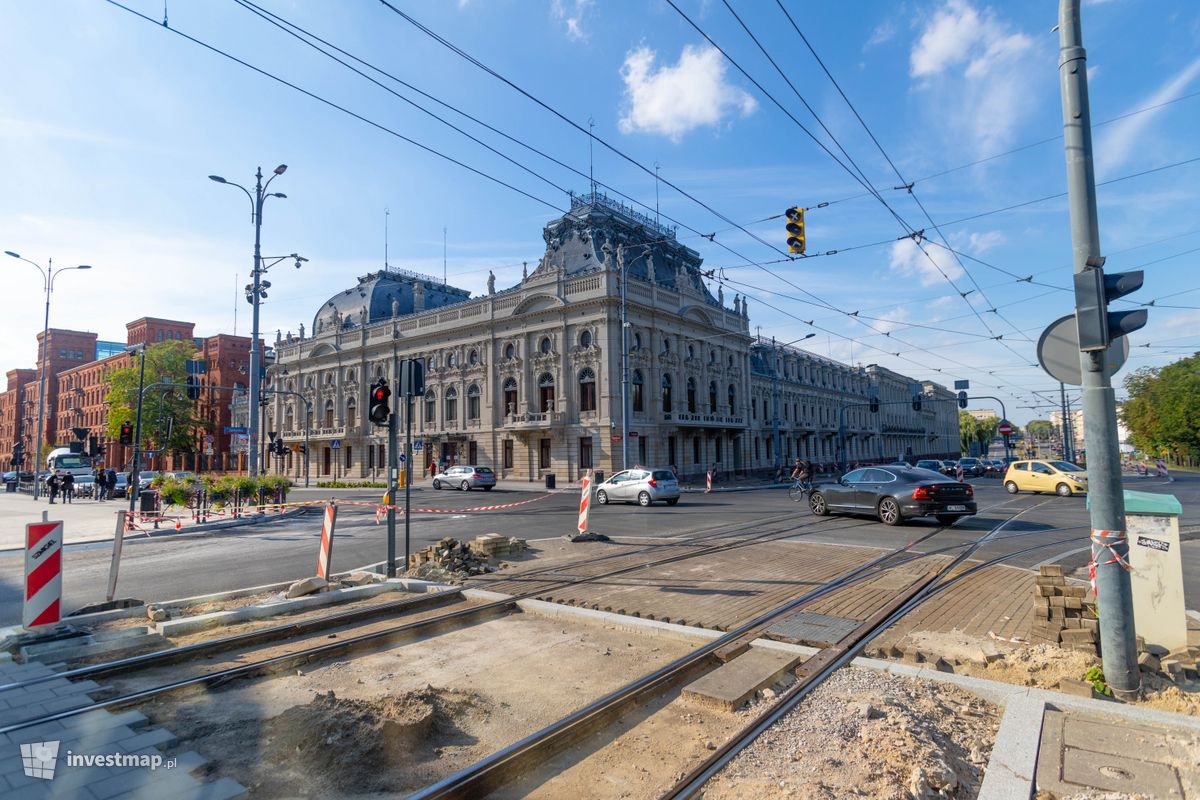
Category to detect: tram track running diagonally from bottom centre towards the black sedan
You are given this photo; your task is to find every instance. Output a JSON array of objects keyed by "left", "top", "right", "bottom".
[{"left": 410, "top": 504, "right": 1061, "bottom": 800}]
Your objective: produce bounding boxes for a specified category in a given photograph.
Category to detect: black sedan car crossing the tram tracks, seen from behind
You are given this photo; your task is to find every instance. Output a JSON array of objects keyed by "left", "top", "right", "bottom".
[{"left": 809, "top": 467, "right": 976, "bottom": 525}]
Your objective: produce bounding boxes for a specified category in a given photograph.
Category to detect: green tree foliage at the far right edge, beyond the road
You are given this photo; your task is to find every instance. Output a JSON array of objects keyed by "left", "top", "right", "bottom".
[{"left": 1120, "top": 354, "right": 1200, "bottom": 459}]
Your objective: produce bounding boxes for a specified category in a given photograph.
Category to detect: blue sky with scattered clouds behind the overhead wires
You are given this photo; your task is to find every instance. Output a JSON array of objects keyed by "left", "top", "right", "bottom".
[{"left": 0, "top": 0, "right": 1200, "bottom": 421}]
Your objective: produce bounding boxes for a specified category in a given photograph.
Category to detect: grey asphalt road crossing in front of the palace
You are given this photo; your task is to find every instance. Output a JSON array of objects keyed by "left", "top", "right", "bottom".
[{"left": 0, "top": 475, "right": 1200, "bottom": 625}]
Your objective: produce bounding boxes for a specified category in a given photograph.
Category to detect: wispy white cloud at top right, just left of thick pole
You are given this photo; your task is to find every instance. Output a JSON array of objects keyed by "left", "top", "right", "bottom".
[{"left": 908, "top": 0, "right": 1039, "bottom": 155}]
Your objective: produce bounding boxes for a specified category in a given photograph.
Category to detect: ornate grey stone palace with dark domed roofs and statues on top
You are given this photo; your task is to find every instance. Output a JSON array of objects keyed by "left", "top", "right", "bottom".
[{"left": 264, "top": 194, "right": 959, "bottom": 480}]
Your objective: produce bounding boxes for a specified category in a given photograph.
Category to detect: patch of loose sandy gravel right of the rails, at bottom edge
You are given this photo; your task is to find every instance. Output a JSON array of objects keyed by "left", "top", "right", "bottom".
[{"left": 703, "top": 669, "right": 1000, "bottom": 800}]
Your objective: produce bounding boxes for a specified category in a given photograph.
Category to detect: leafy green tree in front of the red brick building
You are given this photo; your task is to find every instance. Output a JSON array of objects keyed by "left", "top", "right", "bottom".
[{"left": 104, "top": 342, "right": 204, "bottom": 451}]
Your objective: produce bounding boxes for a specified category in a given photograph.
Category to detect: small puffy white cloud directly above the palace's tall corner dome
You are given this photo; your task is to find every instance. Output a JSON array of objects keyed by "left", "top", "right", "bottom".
[{"left": 620, "top": 44, "right": 758, "bottom": 142}]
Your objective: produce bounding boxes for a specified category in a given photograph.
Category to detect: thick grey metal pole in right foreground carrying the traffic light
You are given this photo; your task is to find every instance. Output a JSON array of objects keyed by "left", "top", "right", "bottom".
[{"left": 1058, "top": 0, "right": 1141, "bottom": 699}]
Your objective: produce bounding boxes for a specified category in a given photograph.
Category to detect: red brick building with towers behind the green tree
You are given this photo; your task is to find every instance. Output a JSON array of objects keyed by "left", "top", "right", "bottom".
[{"left": 0, "top": 317, "right": 250, "bottom": 471}]
